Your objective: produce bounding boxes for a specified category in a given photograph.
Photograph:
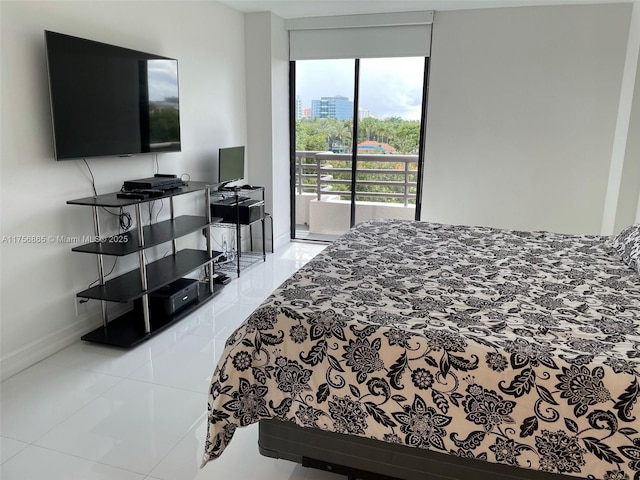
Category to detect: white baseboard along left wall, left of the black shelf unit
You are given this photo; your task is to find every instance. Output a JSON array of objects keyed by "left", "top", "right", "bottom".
[{"left": 0, "top": 315, "right": 102, "bottom": 380}]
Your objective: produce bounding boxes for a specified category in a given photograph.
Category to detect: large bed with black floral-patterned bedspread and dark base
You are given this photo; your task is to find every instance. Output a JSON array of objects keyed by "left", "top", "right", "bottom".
[{"left": 203, "top": 220, "right": 640, "bottom": 480}]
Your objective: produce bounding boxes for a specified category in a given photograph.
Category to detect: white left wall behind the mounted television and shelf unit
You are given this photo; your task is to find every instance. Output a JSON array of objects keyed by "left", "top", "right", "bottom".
[{"left": 0, "top": 1, "right": 246, "bottom": 378}]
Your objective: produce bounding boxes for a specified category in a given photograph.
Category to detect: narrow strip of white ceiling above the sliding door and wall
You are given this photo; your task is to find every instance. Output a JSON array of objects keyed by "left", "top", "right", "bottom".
[{"left": 221, "top": 0, "right": 640, "bottom": 18}]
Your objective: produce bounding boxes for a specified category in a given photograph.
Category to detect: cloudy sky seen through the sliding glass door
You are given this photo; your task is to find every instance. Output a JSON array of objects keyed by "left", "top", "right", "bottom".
[{"left": 296, "top": 57, "right": 424, "bottom": 120}]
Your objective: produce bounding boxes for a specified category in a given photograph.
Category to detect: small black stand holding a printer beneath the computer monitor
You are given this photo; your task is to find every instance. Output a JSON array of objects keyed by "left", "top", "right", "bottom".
[{"left": 211, "top": 186, "right": 273, "bottom": 277}]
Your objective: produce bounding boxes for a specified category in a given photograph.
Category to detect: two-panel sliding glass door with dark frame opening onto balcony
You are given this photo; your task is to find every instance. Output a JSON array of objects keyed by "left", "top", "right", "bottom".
[{"left": 291, "top": 57, "right": 428, "bottom": 240}]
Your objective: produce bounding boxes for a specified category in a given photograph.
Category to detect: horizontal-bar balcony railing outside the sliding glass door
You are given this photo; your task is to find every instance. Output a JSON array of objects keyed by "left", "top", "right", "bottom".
[{"left": 296, "top": 151, "right": 418, "bottom": 207}]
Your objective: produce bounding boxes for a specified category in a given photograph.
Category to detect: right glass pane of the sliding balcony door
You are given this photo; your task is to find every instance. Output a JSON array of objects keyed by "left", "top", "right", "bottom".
[{"left": 355, "top": 57, "right": 425, "bottom": 223}]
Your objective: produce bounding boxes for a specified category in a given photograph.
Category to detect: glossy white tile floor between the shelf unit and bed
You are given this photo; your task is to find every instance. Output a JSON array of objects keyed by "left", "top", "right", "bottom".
[{"left": 0, "top": 243, "right": 345, "bottom": 480}]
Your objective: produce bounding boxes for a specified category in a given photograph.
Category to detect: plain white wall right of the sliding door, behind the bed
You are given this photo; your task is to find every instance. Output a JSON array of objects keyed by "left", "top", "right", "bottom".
[{"left": 422, "top": 4, "right": 632, "bottom": 233}]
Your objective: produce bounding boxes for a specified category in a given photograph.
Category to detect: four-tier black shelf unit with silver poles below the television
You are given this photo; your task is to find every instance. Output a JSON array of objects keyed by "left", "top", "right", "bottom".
[{"left": 67, "top": 182, "right": 223, "bottom": 347}]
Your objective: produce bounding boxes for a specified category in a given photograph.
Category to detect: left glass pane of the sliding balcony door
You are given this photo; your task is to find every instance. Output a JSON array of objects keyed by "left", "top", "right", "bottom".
[{"left": 295, "top": 59, "right": 355, "bottom": 240}]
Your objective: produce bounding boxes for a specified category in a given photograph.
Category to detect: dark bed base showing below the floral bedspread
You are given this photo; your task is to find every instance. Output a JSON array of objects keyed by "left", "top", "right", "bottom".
[{"left": 258, "top": 419, "right": 578, "bottom": 480}]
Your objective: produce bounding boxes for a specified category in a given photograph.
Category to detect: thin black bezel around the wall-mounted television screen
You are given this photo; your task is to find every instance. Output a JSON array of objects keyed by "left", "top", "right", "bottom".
[{"left": 44, "top": 30, "right": 182, "bottom": 161}]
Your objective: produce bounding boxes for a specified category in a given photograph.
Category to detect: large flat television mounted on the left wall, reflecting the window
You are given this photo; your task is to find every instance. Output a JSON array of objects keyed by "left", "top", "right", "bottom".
[{"left": 45, "top": 31, "right": 180, "bottom": 160}]
